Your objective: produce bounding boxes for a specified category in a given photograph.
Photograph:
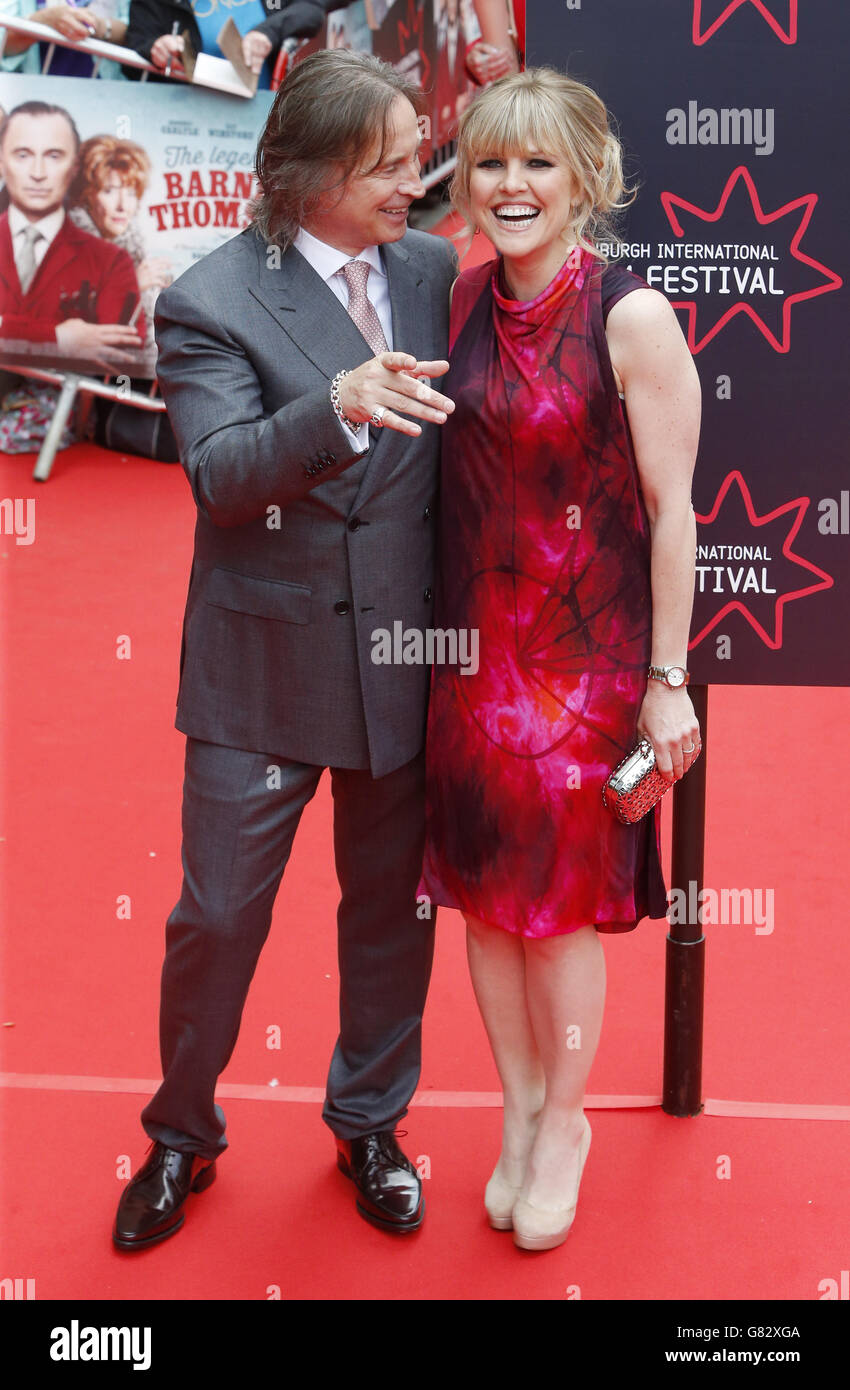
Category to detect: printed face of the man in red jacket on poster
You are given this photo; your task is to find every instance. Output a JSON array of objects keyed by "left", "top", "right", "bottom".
[{"left": 0, "top": 114, "right": 76, "bottom": 222}]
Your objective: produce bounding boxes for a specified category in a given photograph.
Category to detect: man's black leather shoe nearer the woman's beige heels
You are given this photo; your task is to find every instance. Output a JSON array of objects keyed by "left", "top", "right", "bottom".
[{"left": 336, "top": 1130, "right": 425, "bottom": 1234}]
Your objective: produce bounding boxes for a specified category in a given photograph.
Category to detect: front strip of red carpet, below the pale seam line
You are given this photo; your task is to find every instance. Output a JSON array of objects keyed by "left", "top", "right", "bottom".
[{"left": 3, "top": 1084, "right": 847, "bottom": 1301}]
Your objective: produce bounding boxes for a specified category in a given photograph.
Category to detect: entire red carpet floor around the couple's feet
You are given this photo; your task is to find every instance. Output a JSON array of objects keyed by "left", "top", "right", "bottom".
[{"left": 0, "top": 273, "right": 850, "bottom": 1300}]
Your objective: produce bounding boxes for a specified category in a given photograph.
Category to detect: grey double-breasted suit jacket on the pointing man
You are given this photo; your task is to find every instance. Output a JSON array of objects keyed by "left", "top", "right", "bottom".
[{"left": 156, "top": 228, "right": 456, "bottom": 777}]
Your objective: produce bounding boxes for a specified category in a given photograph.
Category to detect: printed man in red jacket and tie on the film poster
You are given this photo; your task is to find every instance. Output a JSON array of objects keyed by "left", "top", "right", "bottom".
[{"left": 0, "top": 101, "right": 144, "bottom": 373}]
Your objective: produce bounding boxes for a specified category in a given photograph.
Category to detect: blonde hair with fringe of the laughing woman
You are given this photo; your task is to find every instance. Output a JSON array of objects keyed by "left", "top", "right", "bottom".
[{"left": 449, "top": 68, "right": 635, "bottom": 260}]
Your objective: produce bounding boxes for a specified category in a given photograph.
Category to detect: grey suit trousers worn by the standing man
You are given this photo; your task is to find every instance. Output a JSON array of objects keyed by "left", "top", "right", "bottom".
[{"left": 142, "top": 738, "right": 433, "bottom": 1158}]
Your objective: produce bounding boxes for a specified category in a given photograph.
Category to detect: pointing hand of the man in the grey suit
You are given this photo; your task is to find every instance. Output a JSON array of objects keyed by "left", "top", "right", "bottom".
[{"left": 339, "top": 352, "right": 454, "bottom": 436}]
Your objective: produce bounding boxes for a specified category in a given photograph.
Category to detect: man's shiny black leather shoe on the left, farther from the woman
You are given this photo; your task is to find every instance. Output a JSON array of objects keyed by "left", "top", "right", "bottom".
[{"left": 113, "top": 1143, "right": 215, "bottom": 1250}]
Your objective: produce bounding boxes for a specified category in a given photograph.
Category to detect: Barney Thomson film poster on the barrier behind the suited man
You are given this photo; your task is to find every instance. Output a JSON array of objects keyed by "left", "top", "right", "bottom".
[{"left": 0, "top": 74, "right": 272, "bottom": 378}]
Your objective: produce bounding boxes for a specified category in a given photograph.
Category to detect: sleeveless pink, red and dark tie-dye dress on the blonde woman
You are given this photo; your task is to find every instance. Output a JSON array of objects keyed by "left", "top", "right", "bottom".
[{"left": 419, "top": 252, "right": 667, "bottom": 937}]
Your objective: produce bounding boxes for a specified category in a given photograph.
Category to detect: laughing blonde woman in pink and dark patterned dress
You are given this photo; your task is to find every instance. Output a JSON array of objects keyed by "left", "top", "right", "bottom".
[{"left": 421, "top": 68, "right": 700, "bottom": 1250}]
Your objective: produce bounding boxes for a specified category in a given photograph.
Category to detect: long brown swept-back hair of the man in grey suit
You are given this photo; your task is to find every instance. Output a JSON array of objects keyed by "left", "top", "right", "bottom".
[{"left": 250, "top": 49, "right": 422, "bottom": 250}]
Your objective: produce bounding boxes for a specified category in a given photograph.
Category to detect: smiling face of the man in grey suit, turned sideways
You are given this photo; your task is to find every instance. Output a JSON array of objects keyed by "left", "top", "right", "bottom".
[{"left": 304, "top": 96, "right": 425, "bottom": 256}]
